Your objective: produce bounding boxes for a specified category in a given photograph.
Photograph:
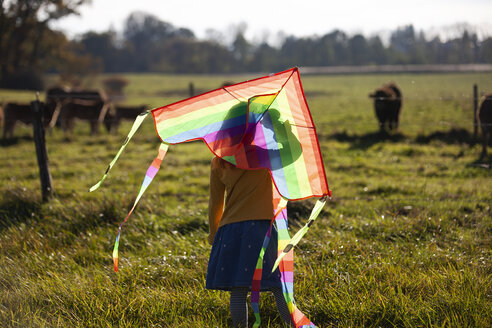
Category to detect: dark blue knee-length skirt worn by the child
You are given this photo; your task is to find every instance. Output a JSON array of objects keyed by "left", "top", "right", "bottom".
[{"left": 205, "top": 220, "right": 281, "bottom": 290}]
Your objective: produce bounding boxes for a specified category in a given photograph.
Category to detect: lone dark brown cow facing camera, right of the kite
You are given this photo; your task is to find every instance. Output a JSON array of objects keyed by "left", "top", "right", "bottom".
[{"left": 369, "top": 82, "right": 403, "bottom": 131}]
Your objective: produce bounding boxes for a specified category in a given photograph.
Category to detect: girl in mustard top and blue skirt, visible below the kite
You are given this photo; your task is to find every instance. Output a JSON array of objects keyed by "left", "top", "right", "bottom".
[{"left": 206, "top": 157, "right": 295, "bottom": 327}]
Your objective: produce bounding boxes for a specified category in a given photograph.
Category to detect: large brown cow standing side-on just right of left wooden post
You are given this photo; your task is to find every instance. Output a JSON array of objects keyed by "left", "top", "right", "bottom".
[{"left": 46, "top": 87, "right": 111, "bottom": 135}]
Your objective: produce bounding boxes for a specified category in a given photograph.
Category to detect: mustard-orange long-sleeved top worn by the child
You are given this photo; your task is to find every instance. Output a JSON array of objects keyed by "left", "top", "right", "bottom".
[{"left": 208, "top": 157, "right": 273, "bottom": 244}]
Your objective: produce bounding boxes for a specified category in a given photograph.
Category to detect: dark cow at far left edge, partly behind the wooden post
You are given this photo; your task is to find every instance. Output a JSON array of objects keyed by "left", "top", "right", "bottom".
[{"left": 3, "top": 102, "right": 51, "bottom": 139}]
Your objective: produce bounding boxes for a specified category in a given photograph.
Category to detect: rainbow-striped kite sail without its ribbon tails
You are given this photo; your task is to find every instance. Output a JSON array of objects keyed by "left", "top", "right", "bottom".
[{"left": 152, "top": 68, "right": 330, "bottom": 200}]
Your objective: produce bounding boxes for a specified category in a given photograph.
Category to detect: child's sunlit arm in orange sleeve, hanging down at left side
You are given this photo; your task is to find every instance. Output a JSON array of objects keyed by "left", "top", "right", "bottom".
[{"left": 208, "top": 159, "right": 225, "bottom": 245}]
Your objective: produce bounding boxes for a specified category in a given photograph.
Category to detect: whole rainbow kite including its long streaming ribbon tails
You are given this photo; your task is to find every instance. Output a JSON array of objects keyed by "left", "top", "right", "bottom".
[{"left": 90, "top": 68, "right": 331, "bottom": 327}]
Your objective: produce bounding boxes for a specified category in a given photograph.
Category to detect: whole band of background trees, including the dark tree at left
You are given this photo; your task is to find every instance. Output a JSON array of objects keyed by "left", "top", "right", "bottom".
[{"left": 0, "top": 0, "right": 492, "bottom": 89}]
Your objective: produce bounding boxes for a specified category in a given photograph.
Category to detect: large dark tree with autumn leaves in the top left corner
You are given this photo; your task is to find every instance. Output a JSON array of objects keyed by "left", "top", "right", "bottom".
[{"left": 0, "top": 0, "right": 87, "bottom": 89}]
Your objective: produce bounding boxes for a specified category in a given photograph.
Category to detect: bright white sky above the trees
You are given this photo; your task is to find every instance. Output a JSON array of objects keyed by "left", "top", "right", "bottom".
[{"left": 56, "top": 0, "right": 492, "bottom": 39}]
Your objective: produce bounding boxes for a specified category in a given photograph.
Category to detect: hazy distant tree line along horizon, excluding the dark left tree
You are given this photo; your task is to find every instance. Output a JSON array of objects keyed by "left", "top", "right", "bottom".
[{"left": 76, "top": 13, "right": 492, "bottom": 73}]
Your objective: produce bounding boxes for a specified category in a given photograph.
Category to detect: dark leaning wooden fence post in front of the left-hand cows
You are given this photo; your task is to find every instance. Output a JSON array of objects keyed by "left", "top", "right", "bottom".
[{"left": 31, "top": 100, "right": 53, "bottom": 202}]
